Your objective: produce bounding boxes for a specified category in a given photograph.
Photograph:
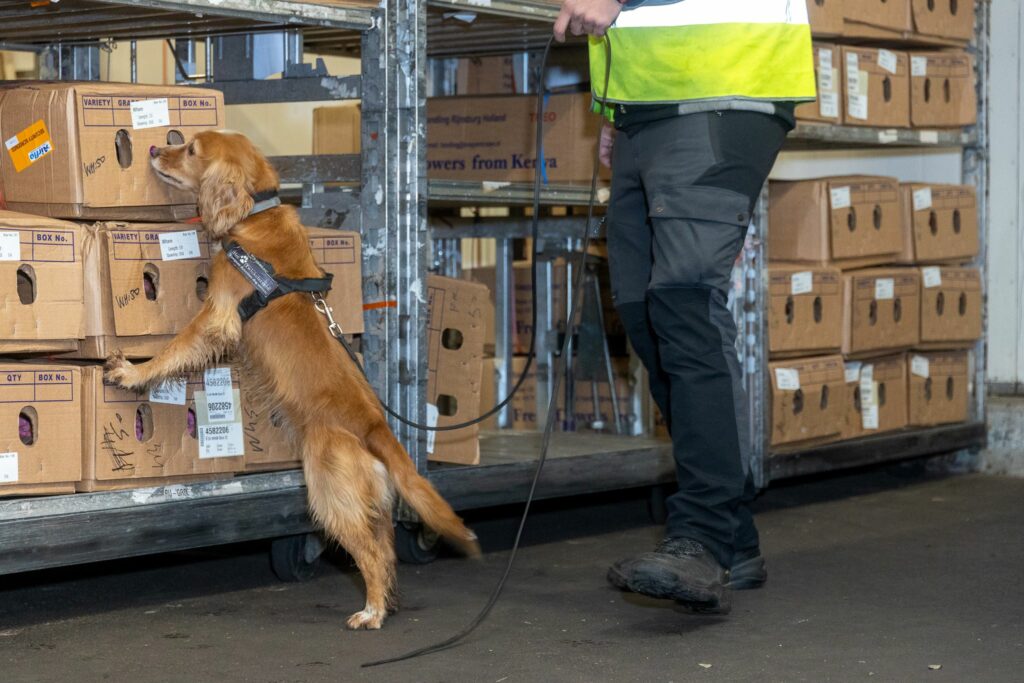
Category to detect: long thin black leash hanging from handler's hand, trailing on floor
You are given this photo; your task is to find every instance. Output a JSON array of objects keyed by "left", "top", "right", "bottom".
[{"left": 360, "top": 37, "right": 611, "bottom": 668}]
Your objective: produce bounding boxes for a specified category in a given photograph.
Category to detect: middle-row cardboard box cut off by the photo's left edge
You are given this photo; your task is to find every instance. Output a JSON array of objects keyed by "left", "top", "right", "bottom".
[{"left": 0, "top": 211, "right": 85, "bottom": 353}]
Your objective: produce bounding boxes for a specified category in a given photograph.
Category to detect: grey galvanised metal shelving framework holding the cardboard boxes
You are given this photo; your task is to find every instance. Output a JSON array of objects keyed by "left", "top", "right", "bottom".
[{"left": 0, "top": 0, "right": 988, "bottom": 574}]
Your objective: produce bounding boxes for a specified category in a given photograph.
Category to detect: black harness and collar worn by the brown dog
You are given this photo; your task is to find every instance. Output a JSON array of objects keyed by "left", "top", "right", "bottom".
[{"left": 222, "top": 189, "right": 334, "bottom": 323}]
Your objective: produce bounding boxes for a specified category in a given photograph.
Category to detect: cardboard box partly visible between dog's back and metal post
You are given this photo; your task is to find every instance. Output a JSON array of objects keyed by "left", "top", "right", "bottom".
[{"left": 306, "top": 227, "right": 366, "bottom": 335}]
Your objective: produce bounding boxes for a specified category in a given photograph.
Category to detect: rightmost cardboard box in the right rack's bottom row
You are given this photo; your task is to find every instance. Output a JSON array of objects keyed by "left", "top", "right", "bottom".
[{"left": 907, "top": 351, "right": 971, "bottom": 427}]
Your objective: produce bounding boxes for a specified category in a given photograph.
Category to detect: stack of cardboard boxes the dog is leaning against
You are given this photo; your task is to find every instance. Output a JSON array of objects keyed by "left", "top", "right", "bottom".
[{"left": 0, "top": 82, "right": 362, "bottom": 496}]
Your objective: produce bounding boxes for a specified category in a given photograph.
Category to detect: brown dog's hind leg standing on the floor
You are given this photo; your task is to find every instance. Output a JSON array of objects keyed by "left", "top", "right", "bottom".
[{"left": 302, "top": 425, "right": 395, "bottom": 629}]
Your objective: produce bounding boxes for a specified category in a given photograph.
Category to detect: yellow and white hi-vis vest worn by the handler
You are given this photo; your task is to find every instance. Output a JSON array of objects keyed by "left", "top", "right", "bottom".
[{"left": 590, "top": 0, "right": 815, "bottom": 103}]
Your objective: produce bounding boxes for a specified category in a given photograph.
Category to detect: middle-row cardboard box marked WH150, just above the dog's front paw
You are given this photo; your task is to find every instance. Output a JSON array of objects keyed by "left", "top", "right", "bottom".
[{"left": 69, "top": 223, "right": 210, "bottom": 360}]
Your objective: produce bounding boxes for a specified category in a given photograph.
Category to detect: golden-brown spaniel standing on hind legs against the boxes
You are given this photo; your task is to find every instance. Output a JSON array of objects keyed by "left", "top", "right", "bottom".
[{"left": 106, "top": 131, "right": 479, "bottom": 629}]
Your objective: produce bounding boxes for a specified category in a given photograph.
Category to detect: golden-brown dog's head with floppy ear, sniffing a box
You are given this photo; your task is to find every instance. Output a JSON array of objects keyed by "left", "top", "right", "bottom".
[{"left": 150, "top": 130, "right": 279, "bottom": 239}]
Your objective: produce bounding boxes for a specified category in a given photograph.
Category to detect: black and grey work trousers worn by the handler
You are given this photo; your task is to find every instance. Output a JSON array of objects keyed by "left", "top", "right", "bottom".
[{"left": 608, "top": 111, "right": 788, "bottom": 567}]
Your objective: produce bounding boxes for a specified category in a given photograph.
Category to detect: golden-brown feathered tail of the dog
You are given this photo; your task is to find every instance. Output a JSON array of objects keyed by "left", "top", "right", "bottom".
[{"left": 366, "top": 422, "right": 480, "bottom": 557}]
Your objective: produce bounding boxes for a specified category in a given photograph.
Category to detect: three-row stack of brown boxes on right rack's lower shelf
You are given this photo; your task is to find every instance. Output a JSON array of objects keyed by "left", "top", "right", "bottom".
[{"left": 768, "top": 176, "right": 983, "bottom": 446}]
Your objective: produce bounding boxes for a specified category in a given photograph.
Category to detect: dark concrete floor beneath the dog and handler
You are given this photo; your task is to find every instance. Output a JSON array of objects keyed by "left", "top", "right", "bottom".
[{"left": 0, "top": 468, "right": 1024, "bottom": 683}]
